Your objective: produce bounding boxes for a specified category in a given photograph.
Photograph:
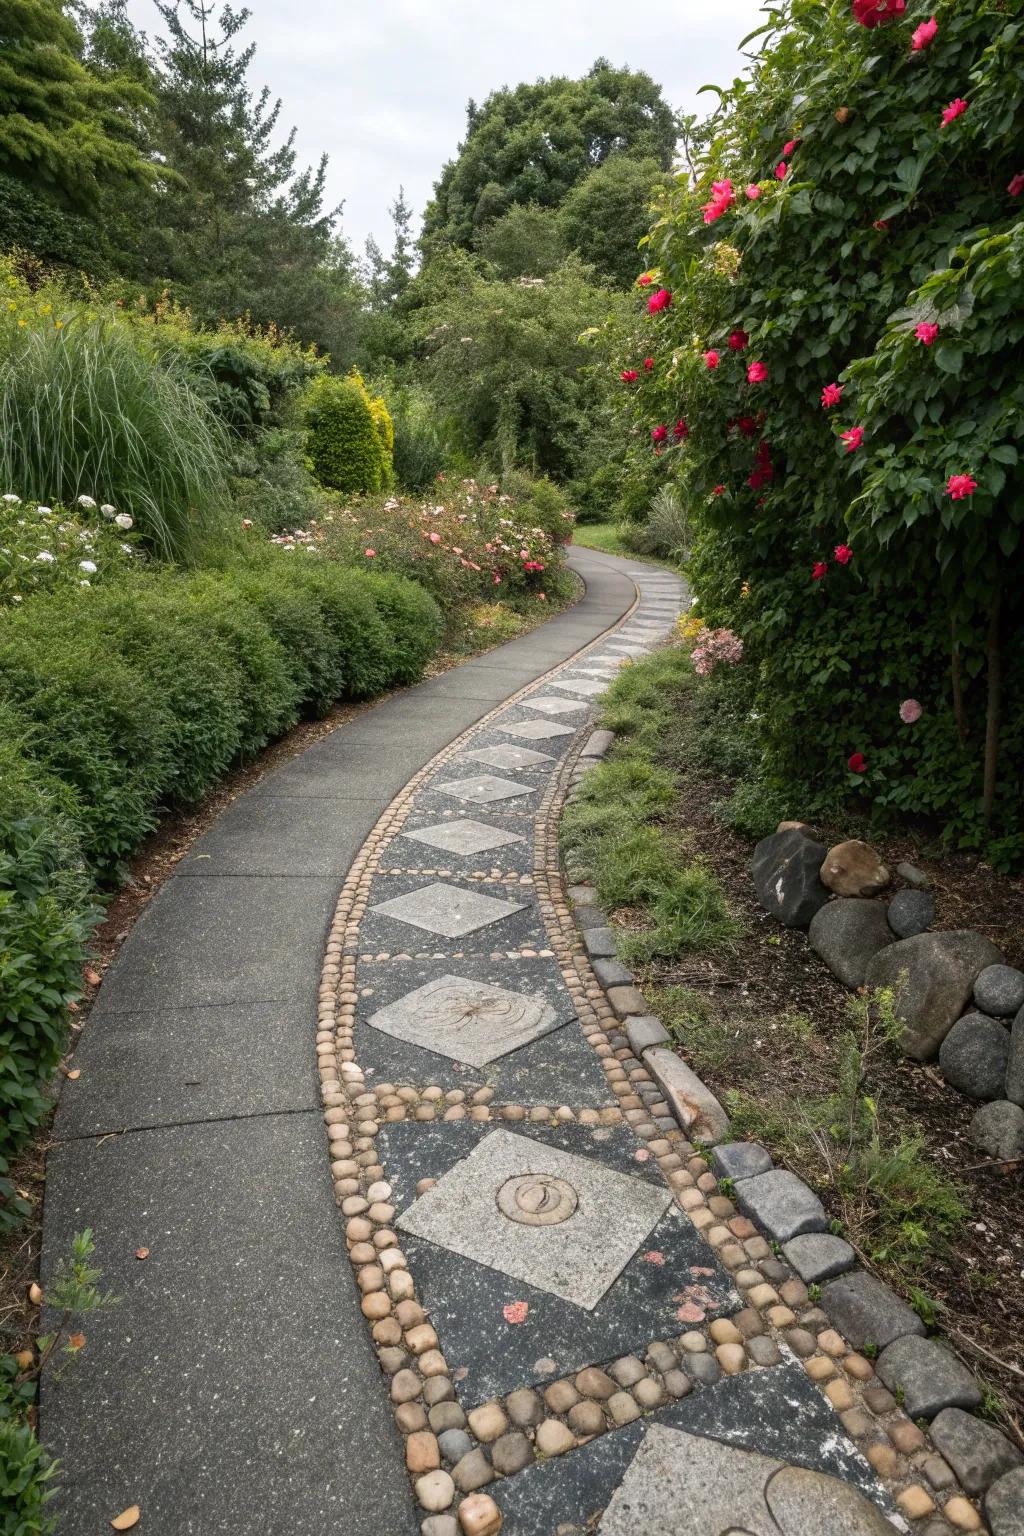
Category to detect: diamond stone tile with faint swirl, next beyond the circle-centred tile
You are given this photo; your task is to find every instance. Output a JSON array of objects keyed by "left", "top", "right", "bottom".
[{"left": 368, "top": 975, "right": 559, "bottom": 1068}]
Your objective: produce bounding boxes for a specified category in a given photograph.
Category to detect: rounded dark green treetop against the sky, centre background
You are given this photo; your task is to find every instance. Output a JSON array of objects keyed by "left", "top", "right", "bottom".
[{"left": 424, "top": 58, "right": 676, "bottom": 249}]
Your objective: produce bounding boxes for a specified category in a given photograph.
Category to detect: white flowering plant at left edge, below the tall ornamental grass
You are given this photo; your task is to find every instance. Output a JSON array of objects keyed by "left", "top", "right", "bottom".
[{"left": 0, "top": 490, "right": 141, "bottom": 608}]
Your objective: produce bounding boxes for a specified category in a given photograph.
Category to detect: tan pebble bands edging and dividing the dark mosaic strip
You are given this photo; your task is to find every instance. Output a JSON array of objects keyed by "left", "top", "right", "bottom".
[{"left": 316, "top": 594, "right": 1000, "bottom": 1536}]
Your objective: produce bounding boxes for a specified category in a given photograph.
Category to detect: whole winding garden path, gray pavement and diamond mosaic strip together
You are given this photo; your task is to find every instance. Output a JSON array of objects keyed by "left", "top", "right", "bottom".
[{"left": 41, "top": 550, "right": 892, "bottom": 1536}]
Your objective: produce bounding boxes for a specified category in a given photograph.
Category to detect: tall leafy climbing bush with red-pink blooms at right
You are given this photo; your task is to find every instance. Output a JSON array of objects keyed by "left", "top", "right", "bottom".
[{"left": 619, "top": 0, "right": 1024, "bottom": 866}]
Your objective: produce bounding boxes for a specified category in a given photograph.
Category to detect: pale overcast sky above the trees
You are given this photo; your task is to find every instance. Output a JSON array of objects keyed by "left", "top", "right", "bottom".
[{"left": 129, "top": 0, "right": 763, "bottom": 252}]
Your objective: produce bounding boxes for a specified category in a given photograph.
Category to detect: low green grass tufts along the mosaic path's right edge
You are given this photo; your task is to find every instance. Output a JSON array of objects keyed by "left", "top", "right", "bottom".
[{"left": 562, "top": 648, "right": 740, "bottom": 963}]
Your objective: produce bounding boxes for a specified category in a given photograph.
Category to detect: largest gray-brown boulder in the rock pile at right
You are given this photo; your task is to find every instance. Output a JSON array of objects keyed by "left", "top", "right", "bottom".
[{"left": 864, "top": 929, "right": 1007, "bottom": 1062}]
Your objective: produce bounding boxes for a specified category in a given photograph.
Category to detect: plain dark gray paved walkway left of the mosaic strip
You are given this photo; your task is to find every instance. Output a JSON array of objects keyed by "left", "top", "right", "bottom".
[{"left": 40, "top": 551, "right": 636, "bottom": 1536}]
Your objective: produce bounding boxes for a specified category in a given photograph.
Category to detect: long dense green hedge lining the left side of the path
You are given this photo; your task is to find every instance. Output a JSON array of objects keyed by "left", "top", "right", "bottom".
[{"left": 0, "top": 550, "right": 442, "bottom": 1198}]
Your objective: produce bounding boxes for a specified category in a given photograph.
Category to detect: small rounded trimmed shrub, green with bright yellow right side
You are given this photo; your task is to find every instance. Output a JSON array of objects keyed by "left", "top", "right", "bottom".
[{"left": 304, "top": 369, "right": 395, "bottom": 492}]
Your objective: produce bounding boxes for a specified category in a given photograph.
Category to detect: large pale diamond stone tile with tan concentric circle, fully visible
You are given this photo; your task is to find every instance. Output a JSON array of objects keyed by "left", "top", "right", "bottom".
[{"left": 396, "top": 1130, "right": 671, "bottom": 1312}]
